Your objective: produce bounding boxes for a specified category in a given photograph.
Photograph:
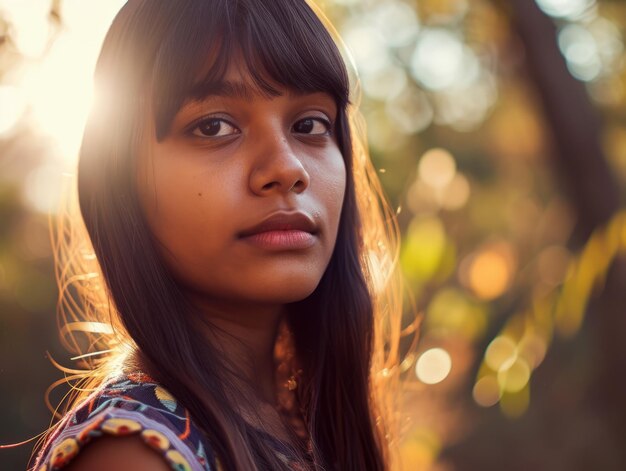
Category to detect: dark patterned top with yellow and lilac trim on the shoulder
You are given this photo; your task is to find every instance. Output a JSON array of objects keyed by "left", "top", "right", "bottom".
[{"left": 32, "top": 373, "right": 300, "bottom": 471}]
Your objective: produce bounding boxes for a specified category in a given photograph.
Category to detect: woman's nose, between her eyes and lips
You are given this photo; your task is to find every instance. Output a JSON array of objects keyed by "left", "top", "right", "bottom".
[{"left": 250, "top": 131, "right": 310, "bottom": 196}]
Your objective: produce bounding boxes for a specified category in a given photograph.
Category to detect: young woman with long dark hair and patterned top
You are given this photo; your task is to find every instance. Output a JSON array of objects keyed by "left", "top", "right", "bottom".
[{"left": 33, "top": 0, "right": 400, "bottom": 471}]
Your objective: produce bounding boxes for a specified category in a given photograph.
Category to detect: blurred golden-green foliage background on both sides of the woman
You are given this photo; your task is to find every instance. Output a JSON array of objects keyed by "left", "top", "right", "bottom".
[{"left": 0, "top": 0, "right": 626, "bottom": 470}]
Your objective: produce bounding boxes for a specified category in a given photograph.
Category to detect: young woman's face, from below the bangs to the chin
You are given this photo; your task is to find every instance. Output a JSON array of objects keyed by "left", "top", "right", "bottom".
[{"left": 138, "top": 61, "right": 346, "bottom": 305}]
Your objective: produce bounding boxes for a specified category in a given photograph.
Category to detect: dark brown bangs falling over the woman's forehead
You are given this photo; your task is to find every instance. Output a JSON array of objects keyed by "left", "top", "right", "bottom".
[{"left": 152, "top": 0, "right": 350, "bottom": 139}]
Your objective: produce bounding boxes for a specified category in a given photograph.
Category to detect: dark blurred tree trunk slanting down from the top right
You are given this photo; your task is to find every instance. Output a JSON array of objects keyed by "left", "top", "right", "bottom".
[{"left": 510, "top": 0, "right": 620, "bottom": 249}]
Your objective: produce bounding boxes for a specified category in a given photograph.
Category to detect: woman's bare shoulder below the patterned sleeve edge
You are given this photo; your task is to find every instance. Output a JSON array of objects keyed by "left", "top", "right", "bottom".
[{"left": 65, "top": 435, "right": 172, "bottom": 471}]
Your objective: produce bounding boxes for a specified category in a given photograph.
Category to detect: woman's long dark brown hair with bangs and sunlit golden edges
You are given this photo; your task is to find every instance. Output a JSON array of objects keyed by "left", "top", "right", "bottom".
[{"left": 35, "top": 0, "right": 401, "bottom": 471}]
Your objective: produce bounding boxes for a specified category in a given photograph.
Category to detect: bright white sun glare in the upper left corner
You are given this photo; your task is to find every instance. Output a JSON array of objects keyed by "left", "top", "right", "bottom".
[{"left": 0, "top": 0, "right": 125, "bottom": 213}]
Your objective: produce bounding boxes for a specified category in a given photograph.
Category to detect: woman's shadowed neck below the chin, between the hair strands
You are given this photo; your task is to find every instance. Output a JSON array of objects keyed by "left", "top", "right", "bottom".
[{"left": 130, "top": 298, "right": 307, "bottom": 450}]
